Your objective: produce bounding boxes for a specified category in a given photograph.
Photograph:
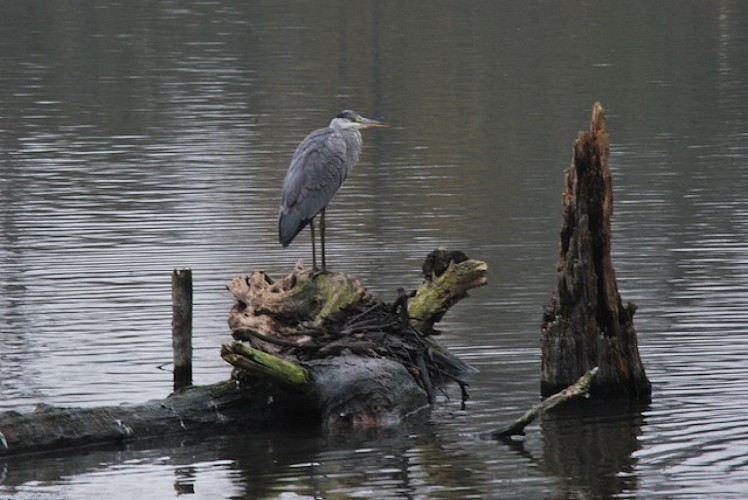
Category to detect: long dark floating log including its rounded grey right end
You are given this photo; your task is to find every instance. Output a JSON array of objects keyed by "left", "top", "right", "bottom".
[{"left": 0, "top": 355, "right": 426, "bottom": 459}]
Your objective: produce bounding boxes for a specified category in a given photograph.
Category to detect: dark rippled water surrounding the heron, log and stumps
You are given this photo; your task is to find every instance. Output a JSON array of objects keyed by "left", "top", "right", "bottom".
[{"left": 0, "top": 0, "right": 748, "bottom": 499}]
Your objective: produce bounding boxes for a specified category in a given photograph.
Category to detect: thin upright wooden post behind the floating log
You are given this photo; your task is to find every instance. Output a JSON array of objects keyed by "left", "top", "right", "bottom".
[{"left": 171, "top": 269, "right": 192, "bottom": 391}]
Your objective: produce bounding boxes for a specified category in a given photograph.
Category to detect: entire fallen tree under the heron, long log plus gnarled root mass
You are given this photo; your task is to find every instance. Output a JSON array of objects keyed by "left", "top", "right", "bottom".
[{"left": 0, "top": 252, "right": 486, "bottom": 458}]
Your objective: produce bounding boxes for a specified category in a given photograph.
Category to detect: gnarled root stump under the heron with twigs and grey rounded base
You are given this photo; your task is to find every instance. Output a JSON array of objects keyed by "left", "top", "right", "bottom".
[{"left": 222, "top": 250, "right": 486, "bottom": 416}]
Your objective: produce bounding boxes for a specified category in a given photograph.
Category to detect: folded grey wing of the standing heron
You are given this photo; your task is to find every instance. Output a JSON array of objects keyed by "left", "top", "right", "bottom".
[{"left": 278, "top": 128, "right": 348, "bottom": 246}]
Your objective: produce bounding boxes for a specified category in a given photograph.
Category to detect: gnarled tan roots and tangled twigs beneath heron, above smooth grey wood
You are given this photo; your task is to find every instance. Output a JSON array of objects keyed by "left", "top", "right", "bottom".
[{"left": 224, "top": 249, "right": 486, "bottom": 406}]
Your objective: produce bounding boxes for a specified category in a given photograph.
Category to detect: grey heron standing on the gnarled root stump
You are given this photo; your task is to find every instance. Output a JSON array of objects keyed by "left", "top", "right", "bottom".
[{"left": 278, "top": 109, "right": 387, "bottom": 272}]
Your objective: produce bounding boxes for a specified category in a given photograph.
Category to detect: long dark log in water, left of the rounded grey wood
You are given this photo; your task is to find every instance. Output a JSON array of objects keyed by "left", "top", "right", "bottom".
[{"left": 0, "top": 380, "right": 311, "bottom": 458}]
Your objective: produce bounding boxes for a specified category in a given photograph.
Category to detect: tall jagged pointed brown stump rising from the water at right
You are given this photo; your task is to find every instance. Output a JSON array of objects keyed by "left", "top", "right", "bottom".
[{"left": 541, "top": 103, "right": 651, "bottom": 399}]
